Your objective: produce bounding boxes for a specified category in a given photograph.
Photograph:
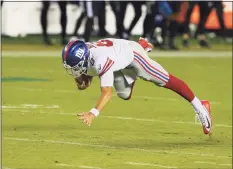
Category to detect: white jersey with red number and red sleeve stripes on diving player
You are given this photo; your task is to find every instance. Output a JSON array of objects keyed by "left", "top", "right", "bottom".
[{"left": 86, "top": 38, "right": 134, "bottom": 87}]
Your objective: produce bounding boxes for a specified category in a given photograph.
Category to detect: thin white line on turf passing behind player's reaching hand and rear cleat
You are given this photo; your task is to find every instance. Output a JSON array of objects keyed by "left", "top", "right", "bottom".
[{"left": 2, "top": 106, "right": 232, "bottom": 128}]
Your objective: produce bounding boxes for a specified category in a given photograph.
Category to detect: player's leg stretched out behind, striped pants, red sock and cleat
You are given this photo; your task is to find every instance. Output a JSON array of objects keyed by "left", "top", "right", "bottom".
[{"left": 132, "top": 43, "right": 212, "bottom": 134}]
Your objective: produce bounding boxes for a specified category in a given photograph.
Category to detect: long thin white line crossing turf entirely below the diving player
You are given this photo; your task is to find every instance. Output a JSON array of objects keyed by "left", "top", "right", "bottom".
[{"left": 3, "top": 137, "right": 231, "bottom": 159}]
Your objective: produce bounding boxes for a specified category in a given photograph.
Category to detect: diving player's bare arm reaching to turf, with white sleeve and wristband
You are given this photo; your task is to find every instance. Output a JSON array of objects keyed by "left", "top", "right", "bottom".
[{"left": 78, "top": 66, "right": 114, "bottom": 126}]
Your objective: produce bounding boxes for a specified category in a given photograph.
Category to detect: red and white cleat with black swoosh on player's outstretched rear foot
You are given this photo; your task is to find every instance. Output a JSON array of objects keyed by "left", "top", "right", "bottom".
[{"left": 198, "top": 100, "right": 212, "bottom": 134}]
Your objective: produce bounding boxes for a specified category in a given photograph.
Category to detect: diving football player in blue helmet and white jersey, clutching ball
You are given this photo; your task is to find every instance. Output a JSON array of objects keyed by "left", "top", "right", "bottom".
[{"left": 62, "top": 38, "right": 212, "bottom": 134}]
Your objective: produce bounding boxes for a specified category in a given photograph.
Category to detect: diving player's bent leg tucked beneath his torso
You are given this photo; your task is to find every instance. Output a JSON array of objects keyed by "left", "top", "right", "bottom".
[{"left": 114, "top": 71, "right": 135, "bottom": 100}]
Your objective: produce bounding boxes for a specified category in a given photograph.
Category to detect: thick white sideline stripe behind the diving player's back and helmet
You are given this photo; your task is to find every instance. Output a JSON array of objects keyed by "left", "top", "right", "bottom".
[{"left": 2, "top": 50, "right": 232, "bottom": 58}]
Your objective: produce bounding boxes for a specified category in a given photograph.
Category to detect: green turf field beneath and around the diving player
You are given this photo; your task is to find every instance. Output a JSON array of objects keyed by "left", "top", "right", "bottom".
[{"left": 2, "top": 42, "right": 232, "bottom": 169}]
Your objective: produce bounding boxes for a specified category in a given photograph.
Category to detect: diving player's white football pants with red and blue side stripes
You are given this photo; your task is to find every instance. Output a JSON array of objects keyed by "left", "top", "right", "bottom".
[{"left": 114, "top": 41, "right": 169, "bottom": 100}]
